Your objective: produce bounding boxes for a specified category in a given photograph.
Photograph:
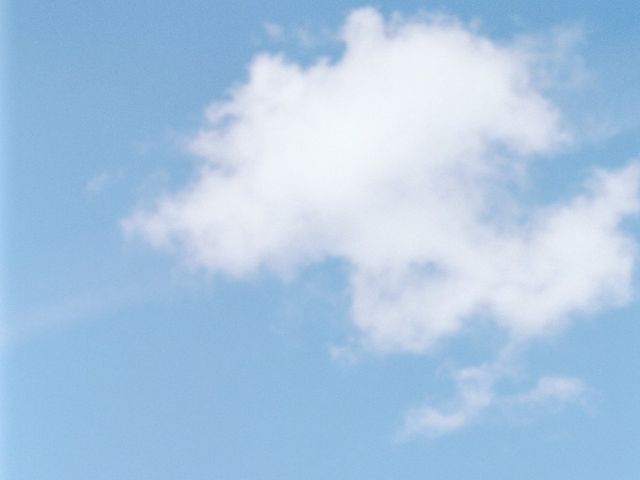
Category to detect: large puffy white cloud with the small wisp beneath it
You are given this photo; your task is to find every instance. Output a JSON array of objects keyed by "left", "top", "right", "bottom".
[{"left": 124, "top": 8, "right": 640, "bottom": 436}]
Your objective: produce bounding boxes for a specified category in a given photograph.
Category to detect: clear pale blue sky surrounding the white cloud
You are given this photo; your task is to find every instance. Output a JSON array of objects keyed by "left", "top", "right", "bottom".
[{"left": 2, "top": 0, "right": 640, "bottom": 480}]
